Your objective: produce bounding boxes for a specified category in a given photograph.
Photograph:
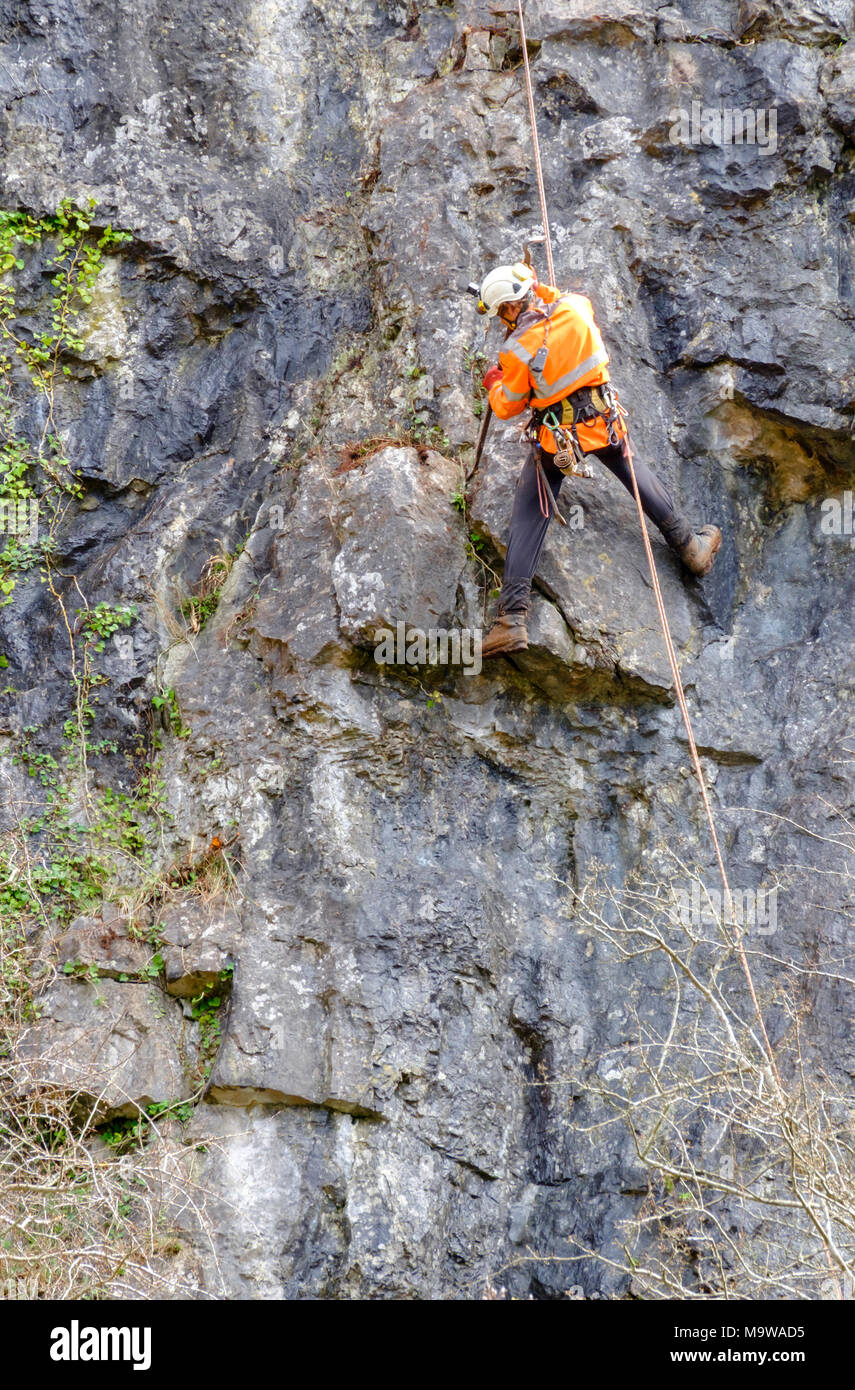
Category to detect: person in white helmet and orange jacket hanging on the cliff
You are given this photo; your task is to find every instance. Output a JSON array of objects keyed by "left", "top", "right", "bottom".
[{"left": 473, "top": 261, "right": 722, "bottom": 656}]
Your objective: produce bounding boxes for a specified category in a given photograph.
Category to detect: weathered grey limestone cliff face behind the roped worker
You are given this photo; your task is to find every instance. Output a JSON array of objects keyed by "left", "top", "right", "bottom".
[{"left": 0, "top": 0, "right": 855, "bottom": 1300}]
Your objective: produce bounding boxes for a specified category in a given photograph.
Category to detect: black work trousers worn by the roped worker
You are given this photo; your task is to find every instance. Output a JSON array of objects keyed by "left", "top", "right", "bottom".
[{"left": 499, "top": 445, "right": 692, "bottom": 613}]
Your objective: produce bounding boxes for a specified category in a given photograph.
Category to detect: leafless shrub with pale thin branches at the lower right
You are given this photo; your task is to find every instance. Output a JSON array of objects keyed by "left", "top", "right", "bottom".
[{"left": 547, "top": 844, "right": 855, "bottom": 1300}]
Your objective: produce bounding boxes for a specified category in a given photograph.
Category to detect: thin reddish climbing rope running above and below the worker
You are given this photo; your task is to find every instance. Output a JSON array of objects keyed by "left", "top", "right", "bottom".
[{"left": 517, "top": 0, "right": 783, "bottom": 1093}]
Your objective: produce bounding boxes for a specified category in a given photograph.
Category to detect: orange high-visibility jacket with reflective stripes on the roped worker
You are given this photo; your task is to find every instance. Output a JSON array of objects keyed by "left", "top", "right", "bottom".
[{"left": 489, "top": 284, "right": 623, "bottom": 453}]
